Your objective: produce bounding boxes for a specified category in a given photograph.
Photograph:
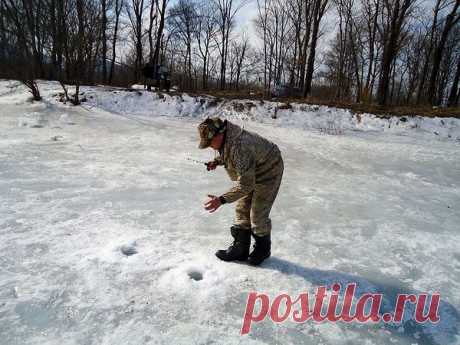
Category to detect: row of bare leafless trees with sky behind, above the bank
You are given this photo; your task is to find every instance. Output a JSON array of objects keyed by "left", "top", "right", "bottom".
[{"left": 0, "top": 0, "right": 460, "bottom": 106}]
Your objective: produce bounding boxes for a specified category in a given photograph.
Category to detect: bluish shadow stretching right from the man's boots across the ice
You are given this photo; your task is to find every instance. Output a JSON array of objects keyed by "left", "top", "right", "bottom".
[{"left": 261, "top": 256, "right": 460, "bottom": 345}]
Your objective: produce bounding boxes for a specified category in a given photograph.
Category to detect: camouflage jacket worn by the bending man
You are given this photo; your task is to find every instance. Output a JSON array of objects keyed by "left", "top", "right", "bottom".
[{"left": 216, "top": 121, "right": 282, "bottom": 203}]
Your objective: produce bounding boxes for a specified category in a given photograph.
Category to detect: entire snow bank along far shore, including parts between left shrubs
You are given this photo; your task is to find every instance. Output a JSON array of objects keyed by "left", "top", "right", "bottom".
[{"left": 0, "top": 80, "right": 460, "bottom": 140}]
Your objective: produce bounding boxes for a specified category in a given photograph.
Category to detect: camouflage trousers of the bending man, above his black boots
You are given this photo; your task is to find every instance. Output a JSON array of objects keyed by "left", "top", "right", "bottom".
[{"left": 235, "top": 155, "right": 284, "bottom": 236}]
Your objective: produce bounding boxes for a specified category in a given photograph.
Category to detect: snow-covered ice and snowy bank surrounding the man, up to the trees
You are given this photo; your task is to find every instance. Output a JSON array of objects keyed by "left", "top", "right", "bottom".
[{"left": 0, "top": 80, "right": 460, "bottom": 345}]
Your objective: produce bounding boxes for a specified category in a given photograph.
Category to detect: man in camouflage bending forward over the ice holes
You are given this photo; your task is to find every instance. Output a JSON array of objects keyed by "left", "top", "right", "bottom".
[{"left": 198, "top": 117, "right": 284, "bottom": 265}]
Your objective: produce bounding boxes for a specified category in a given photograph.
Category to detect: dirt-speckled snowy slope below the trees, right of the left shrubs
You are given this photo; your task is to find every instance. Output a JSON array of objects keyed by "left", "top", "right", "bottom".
[{"left": 95, "top": 82, "right": 460, "bottom": 140}]
